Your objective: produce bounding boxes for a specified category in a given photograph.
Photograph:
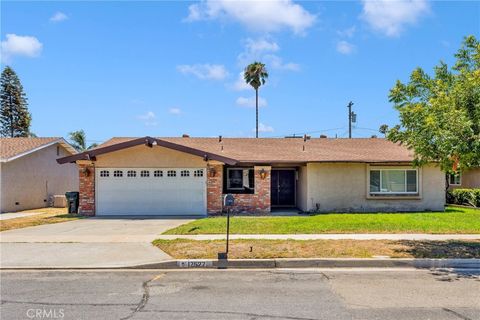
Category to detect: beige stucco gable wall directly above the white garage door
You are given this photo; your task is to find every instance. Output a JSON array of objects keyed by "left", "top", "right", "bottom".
[{"left": 95, "top": 145, "right": 207, "bottom": 168}]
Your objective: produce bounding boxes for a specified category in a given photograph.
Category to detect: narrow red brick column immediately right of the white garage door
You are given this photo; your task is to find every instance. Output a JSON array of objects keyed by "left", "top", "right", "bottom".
[{"left": 207, "top": 162, "right": 223, "bottom": 214}]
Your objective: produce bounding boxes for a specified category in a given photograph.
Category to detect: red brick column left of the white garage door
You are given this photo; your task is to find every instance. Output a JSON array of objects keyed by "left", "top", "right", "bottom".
[{"left": 77, "top": 161, "right": 95, "bottom": 216}]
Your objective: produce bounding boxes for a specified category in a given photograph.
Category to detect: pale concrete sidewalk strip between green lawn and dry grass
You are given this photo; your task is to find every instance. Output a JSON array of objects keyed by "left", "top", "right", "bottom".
[{"left": 157, "top": 233, "right": 480, "bottom": 241}]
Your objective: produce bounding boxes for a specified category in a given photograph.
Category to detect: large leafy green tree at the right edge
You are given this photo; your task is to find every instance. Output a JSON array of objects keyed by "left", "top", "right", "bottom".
[{"left": 387, "top": 36, "right": 480, "bottom": 173}]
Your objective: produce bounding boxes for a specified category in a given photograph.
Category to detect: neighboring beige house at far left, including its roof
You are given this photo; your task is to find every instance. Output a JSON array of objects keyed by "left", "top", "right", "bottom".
[{"left": 0, "top": 138, "right": 78, "bottom": 212}]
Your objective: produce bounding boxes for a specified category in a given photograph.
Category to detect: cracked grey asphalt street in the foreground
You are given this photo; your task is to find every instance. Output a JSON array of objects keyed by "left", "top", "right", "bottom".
[{"left": 0, "top": 269, "right": 480, "bottom": 320}]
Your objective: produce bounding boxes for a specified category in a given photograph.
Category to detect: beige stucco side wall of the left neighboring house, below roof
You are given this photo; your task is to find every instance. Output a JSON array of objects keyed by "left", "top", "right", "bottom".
[{"left": 0, "top": 144, "right": 78, "bottom": 212}]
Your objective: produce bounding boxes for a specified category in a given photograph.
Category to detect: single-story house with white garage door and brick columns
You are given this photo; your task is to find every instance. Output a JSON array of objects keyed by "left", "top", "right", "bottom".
[{"left": 57, "top": 135, "right": 445, "bottom": 216}]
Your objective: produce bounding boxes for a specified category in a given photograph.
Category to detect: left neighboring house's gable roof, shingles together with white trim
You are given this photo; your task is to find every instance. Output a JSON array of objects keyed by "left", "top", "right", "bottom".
[{"left": 0, "top": 137, "right": 76, "bottom": 162}]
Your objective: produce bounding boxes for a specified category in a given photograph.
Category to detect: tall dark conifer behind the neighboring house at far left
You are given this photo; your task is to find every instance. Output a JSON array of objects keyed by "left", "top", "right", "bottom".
[{"left": 0, "top": 66, "right": 32, "bottom": 138}]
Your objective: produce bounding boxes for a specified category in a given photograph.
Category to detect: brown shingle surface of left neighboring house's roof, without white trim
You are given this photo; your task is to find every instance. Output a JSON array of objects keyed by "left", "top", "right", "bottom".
[{"left": 0, "top": 137, "right": 63, "bottom": 160}]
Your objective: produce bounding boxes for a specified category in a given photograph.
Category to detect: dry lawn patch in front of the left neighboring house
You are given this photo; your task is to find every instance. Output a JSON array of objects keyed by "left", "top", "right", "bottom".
[{"left": 0, "top": 208, "right": 83, "bottom": 231}]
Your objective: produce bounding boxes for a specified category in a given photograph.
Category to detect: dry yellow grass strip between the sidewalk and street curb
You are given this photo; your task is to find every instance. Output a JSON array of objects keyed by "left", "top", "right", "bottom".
[{"left": 153, "top": 239, "right": 480, "bottom": 259}]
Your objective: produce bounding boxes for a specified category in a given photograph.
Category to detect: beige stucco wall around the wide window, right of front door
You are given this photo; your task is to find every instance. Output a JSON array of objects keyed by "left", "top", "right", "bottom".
[{"left": 307, "top": 163, "right": 445, "bottom": 212}]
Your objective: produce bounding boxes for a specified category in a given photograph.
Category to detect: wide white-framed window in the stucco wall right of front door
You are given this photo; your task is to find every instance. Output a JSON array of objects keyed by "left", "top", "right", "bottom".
[{"left": 370, "top": 169, "right": 418, "bottom": 195}]
